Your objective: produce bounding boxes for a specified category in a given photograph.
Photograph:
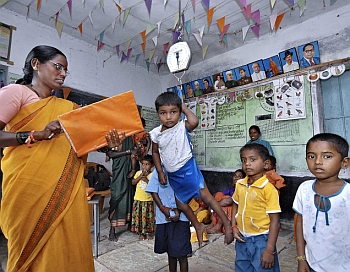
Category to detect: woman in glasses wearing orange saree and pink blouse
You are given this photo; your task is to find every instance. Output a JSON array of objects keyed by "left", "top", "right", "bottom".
[{"left": 0, "top": 46, "right": 100, "bottom": 272}]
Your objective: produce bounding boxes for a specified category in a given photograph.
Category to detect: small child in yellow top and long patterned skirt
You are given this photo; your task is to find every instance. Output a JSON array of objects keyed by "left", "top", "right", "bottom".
[{"left": 131, "top": 155, "right": 154, "bottom": 240}]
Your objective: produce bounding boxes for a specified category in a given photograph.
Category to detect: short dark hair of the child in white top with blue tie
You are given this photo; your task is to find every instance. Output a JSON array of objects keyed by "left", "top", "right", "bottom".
[{"left": 306, "top": 133, "right": 349, "bottom": 159}]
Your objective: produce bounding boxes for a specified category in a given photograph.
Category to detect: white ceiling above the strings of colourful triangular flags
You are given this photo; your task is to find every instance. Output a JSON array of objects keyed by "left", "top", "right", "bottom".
[{"left": 0, "top": 0, "right": 348, "bottom": 75}]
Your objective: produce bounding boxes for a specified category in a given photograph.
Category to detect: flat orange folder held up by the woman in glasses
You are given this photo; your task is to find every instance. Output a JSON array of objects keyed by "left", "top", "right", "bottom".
[{"left": 58, "top": 91, "right": 143, "bottom": 157}]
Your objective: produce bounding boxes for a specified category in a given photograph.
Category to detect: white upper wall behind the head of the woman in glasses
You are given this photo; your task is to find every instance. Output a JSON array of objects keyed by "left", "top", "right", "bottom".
[{"left": 0, "top": 8, "right": 161, "bottom": 107}]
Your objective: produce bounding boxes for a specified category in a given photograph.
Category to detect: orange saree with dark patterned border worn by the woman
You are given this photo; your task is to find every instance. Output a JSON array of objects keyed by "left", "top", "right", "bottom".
[{"left": 0, "top": 97, "right": 94, "bottom": 272}]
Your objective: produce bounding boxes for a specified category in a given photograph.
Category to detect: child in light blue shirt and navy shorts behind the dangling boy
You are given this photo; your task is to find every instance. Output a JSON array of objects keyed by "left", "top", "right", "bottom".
[{"left": 146, "top": 171, "right": 192, "bottom": 272}]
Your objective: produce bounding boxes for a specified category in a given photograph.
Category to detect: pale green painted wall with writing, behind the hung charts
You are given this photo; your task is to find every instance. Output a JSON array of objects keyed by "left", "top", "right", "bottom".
[{"left": 142, "top": 76, "right": 313, "bottom": 172}]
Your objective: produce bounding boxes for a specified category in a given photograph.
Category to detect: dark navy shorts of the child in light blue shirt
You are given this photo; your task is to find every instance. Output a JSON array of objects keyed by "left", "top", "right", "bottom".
[{"left": 154, "top": 221, "right": 192, "bottom": 258}]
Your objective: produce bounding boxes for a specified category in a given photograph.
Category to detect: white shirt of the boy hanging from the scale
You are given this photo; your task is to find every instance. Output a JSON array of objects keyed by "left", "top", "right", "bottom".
[{"left": 149, "top": 121, "right": 192, "bottom": 173}]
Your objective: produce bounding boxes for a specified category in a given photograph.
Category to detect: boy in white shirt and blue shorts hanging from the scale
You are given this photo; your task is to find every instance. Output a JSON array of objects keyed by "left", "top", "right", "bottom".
[{"left": 150, "top": 92, "right": 232, "bottom": 247}]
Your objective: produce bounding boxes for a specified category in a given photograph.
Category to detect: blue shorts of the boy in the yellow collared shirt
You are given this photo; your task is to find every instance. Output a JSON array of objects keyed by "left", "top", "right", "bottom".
[{"left": 235, "top": 234, "right": 280, "bottom": 272}]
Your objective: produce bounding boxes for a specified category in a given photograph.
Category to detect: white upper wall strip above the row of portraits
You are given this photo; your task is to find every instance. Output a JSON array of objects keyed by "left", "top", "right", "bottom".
[{"left": 161, "top": 3, "right": 350, "bottom": 88}]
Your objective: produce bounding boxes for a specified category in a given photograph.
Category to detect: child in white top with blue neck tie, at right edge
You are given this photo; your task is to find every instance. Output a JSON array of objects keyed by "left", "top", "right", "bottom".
[{"left": 293, "top": 133, "right": 350, "bottom": 272}]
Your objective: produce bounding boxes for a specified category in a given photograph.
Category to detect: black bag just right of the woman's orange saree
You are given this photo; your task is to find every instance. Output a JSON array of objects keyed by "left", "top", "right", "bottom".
[{"left": 84, "top": 164, "right": 111, "bottom": 191}]
